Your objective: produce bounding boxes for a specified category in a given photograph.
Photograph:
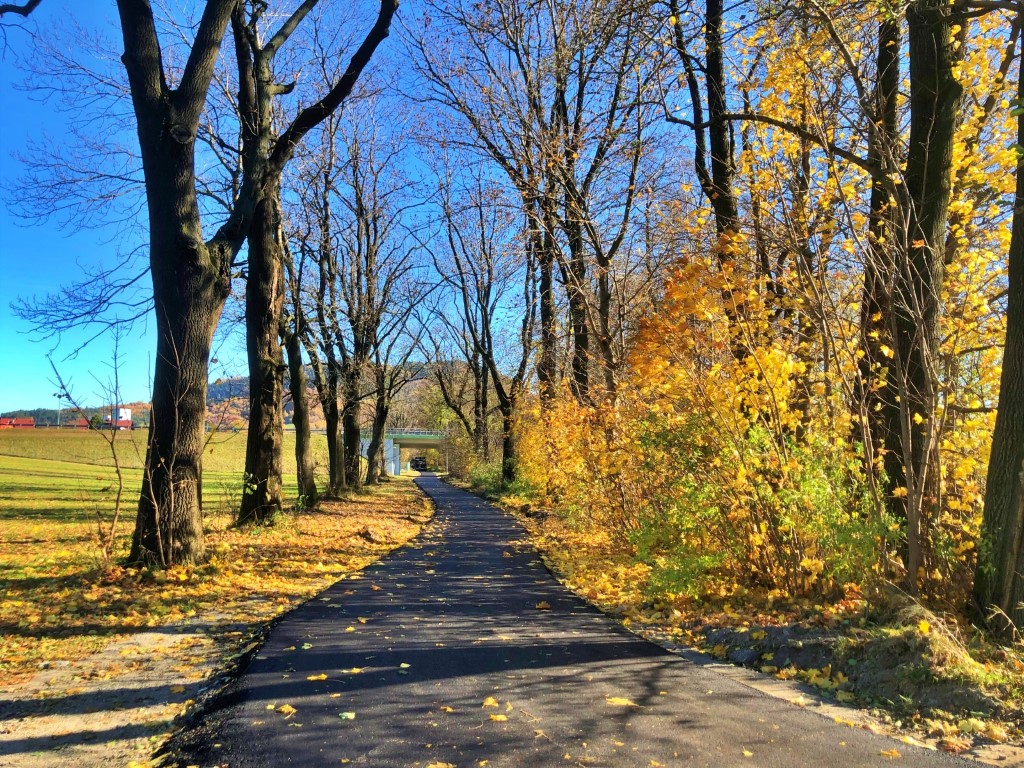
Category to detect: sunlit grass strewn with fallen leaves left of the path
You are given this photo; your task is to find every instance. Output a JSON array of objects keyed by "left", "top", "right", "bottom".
[{"left": 0, "top": 450, "right": 430, "bottom": 684}]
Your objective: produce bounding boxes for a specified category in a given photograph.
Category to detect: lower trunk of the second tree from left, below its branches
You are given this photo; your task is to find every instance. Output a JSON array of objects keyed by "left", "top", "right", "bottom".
[{"left": 239, "top": 189, "right": 285, "bottom": 524}]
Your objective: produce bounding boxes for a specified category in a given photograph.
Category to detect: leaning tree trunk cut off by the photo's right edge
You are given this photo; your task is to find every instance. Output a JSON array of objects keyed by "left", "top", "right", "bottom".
[{"left": 974, "top": 46, "right": 1024, "bottom": 639}]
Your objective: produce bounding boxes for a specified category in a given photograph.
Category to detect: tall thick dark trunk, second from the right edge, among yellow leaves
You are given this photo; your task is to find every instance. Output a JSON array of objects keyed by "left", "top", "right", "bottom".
[{"left": 889, "top": 0, "right": 963, "bottom": 589}]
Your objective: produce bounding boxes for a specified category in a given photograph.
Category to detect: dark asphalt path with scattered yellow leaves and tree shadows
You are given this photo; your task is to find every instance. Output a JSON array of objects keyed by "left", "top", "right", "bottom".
[{"left": 169, "top": 476, "right": 966, "bottom": 768}]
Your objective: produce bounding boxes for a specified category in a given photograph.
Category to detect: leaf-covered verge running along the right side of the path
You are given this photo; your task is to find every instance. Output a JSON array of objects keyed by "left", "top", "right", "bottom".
[{"left": 458, "top": 473, "right": 1024, "bottom": 754}]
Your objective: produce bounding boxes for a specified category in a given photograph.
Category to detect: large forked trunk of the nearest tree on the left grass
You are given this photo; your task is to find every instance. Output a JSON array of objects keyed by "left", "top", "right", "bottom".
[{"left": 118, "top": 0, "right": 237, "bottom": 567}]
